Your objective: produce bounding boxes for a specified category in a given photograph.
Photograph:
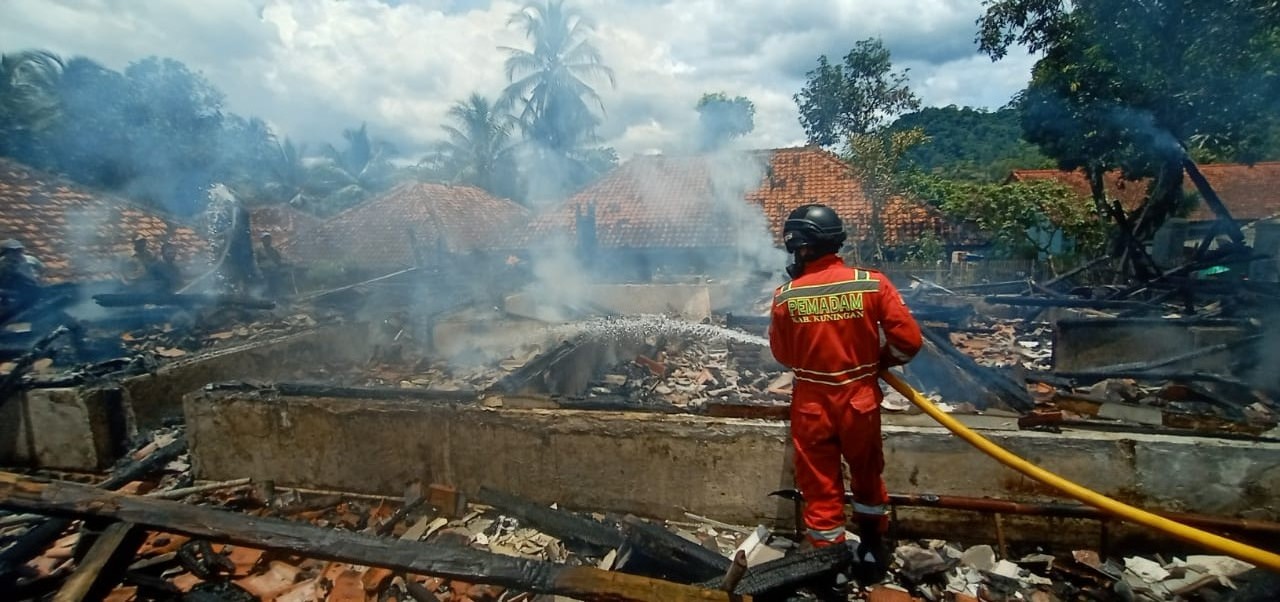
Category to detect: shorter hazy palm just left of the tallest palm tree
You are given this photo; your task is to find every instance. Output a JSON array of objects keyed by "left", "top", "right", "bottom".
[{"left": 425, "top": 94, "right": 511, "bottom": 193}]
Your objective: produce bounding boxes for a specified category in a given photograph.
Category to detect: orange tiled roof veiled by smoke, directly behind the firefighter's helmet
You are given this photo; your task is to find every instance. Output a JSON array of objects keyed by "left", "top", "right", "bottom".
[{"left": 522, "top": 147, "right": 947, "bottom": 248}]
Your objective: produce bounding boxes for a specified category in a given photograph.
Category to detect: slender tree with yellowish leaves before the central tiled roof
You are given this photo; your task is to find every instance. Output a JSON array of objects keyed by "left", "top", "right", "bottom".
[{"left": 845, "top": 129, "right": 925, "bottom": 261}]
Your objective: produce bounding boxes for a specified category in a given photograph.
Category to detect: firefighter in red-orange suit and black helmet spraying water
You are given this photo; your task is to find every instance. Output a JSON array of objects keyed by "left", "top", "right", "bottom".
[{"left": 769, "top": 205, "right": 922, "bottom": 582}]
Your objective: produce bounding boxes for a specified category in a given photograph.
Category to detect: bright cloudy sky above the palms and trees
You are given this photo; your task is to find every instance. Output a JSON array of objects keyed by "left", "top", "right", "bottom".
[{"left": 0, "top": 0, "right": 1032, "bottom": 158}]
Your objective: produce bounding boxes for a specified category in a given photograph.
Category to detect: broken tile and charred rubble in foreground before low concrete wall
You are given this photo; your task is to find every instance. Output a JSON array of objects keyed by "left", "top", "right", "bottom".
[{"left": 0, "top": 429, "right": 1270, "bottom": 602}]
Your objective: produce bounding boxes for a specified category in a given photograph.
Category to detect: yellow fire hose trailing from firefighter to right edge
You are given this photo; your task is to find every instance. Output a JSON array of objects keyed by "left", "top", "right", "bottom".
[{"left": 879, "top": 370, "right": 1280, "bottom": 573}]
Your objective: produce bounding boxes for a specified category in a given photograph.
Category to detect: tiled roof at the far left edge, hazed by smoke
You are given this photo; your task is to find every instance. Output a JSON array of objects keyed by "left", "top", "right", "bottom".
[{"left": 0, "top": 159, "right": 209, "bottom": 283}]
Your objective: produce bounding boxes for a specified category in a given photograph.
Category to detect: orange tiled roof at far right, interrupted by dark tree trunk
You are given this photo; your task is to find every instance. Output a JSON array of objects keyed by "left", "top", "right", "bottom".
[{"left": 1009, "top": 161, "right": 1280, "bottom": 222}]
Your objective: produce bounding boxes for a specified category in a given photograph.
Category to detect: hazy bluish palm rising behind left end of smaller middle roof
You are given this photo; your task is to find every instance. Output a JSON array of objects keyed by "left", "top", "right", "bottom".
[{"left": 315, "top": 123, "right": 396, "bottom": 214}]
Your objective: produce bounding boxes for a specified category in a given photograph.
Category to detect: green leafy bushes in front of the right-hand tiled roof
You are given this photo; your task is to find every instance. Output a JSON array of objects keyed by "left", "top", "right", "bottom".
[{"left": 902, "top": 172, "right": 1107, "bottom": 257}]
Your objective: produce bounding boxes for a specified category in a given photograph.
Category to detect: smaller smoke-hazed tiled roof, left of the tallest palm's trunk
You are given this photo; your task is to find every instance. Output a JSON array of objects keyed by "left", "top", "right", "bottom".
[{"left": 284, "top": 183, "right": 529, "bottom": 269}]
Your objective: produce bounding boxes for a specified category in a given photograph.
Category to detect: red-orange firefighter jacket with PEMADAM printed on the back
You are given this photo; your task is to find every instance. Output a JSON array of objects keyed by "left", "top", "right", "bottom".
[{"left": 769, "top": 255, "right": 922, "bottom": 412}]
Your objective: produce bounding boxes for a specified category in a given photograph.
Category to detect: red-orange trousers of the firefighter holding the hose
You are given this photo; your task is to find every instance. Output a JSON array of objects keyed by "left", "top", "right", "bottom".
[{"left": 791, "top": 400, "right": 888, "bottom": 533}]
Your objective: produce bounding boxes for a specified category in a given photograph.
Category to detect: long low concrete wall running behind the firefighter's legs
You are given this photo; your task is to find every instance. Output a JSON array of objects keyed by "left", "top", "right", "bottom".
[{"left": 186, "top": 392, "right": 1280, "bottom": 537}]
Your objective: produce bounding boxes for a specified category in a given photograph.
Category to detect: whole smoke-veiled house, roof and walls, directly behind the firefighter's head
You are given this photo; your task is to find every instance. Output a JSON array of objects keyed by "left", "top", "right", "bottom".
[{"left": 518, "top": 147, "right": 972, "bottom": 279}]
